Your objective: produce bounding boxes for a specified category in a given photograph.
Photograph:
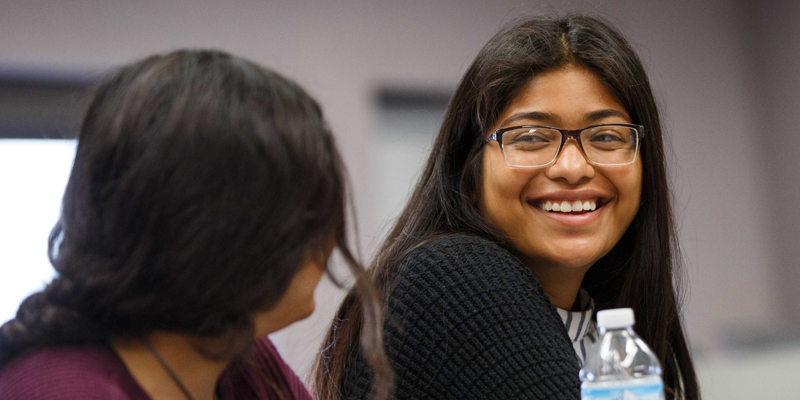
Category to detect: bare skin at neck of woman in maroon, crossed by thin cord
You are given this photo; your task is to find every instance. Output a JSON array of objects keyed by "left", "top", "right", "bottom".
[{"left": 110, "top": 332, "right": 228, "bottom": 400}]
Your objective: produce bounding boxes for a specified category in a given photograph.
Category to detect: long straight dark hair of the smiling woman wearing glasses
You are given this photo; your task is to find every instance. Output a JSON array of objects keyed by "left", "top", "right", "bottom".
[{"left": 316, "top": 16, "right": 700, "bottom": 399}]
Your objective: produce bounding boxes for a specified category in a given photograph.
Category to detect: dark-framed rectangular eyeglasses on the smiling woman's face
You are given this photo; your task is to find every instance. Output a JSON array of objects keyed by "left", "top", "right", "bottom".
[{"left": 485, "top": 124, "right": 644, "bottom": 168}]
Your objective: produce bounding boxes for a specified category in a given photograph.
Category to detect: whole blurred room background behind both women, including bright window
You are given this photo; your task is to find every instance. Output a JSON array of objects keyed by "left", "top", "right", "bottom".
[{"left": 0, "top": 0, "right": 800, "bottom": 399}]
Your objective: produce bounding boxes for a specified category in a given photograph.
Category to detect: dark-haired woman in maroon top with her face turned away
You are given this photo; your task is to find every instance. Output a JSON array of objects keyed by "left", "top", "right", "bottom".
[{"left": 0, "top": 51, "right": 388, "bottom": 400}]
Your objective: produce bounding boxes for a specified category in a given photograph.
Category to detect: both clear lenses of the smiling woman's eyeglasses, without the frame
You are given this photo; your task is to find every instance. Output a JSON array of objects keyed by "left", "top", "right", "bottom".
[{"left": 502, "top": 125, "right": 638, "bottom": 167}]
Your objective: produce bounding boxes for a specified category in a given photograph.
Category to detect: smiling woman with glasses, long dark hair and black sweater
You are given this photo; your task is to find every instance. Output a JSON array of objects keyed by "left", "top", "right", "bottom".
[{"left": 316, "top": 16, "right": 699, "bottom": 400}]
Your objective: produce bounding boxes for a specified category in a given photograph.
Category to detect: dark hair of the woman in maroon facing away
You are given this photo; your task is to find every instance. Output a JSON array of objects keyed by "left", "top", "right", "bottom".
[{"left": 0, "top": 50, "right": 386, "bottom": 396}]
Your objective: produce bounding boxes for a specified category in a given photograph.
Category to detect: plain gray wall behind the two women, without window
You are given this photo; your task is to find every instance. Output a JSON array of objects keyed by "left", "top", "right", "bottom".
[{"left": 0, "top": 0, "right": 800, "bottom": 382}]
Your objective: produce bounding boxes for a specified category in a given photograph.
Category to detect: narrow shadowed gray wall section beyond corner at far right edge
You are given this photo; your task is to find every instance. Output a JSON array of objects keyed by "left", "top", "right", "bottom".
[{"left": 747, "top": 0, "right": 800, "bottom": 335}]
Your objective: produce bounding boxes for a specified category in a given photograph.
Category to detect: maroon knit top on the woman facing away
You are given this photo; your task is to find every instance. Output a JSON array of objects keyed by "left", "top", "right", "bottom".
[{"left": 0, "top": 337, "right": 313, "bottom": 400}]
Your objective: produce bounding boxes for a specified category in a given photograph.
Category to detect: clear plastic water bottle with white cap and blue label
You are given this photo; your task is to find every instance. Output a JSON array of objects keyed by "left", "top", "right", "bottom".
[{"left": 580, "top": 308, "right": 664, "bottom": 400}]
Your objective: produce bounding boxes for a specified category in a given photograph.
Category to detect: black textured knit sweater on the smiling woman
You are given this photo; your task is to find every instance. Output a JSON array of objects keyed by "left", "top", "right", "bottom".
[{"left": 343, "top": 236, "right": 580, "bottom": 400}]
